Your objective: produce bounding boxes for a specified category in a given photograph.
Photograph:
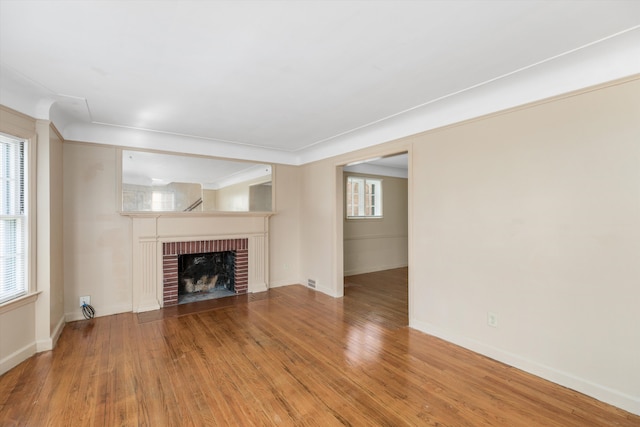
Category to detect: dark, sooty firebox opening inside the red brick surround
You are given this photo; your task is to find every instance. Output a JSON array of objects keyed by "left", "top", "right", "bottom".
[{"left": 178, "top": 251, "right": 236, "bottom": 304}]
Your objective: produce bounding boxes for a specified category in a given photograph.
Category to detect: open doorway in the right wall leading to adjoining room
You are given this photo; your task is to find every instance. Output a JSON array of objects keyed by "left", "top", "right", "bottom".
[{"left": 336, "top": 152, "right": 409, "bottom": 323}]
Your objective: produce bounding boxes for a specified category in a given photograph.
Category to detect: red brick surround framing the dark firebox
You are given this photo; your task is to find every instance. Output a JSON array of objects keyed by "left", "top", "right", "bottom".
[{"left": 162, "top": 239, "right": 249, "bottom": 307}]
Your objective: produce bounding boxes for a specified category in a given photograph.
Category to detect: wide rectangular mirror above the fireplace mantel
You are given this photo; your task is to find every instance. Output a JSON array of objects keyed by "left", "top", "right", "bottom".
[{"left": 121, "top": 150, "right": 273, "bottom": 213}]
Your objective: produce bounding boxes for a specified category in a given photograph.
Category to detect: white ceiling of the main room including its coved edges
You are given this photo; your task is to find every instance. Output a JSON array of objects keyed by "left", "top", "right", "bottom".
[{"left": 0, "top": 0, "right": 640, "bottom": 164}]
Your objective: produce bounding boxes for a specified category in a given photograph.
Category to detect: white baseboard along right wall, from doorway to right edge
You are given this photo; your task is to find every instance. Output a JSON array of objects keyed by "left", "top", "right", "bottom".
[{"left": 409, "top": 320, "right": 640, "bottom": 415}]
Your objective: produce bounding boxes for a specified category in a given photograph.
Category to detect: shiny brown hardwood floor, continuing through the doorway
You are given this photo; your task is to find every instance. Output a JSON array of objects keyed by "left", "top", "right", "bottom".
[{"left": 0, "top": 269, "right": 640, "bottom": 427}]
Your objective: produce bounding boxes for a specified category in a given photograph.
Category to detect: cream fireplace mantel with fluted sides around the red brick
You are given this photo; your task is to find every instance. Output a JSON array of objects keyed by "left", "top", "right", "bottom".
[{"left": 131, "top": 214, "right": 270, "bottom": 313}]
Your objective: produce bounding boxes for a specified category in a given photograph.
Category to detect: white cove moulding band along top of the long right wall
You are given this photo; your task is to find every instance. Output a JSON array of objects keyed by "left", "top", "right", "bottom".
[{"left": 296, "top": 26, "right": 640, "bottom": 165}]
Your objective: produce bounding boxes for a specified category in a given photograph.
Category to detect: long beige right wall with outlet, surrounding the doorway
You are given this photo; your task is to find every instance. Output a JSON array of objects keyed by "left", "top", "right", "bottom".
[{"left": 300, "top": 80, "right": 640, "bottom": 413}]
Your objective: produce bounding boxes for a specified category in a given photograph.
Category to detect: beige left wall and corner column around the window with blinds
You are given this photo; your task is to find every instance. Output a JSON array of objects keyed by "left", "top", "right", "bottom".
[{"left": 0, "top": 107, "right": 64, "bottom": 374}]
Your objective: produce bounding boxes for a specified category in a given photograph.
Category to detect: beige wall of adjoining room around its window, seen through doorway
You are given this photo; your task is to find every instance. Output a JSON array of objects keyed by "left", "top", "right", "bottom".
[{"left": 343, "top": 172, "right": 408, "bottom": 276}]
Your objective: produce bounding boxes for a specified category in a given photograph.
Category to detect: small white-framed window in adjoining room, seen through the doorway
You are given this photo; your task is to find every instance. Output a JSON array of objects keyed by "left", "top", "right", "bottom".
[{"left": 346, "top": 176, "right": 382, "bottom": 218}]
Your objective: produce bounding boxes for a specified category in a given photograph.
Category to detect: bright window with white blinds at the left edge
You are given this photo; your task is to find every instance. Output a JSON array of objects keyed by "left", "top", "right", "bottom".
[{"left": 0, "top": 134, "right": 28, "bottom": 304}]
